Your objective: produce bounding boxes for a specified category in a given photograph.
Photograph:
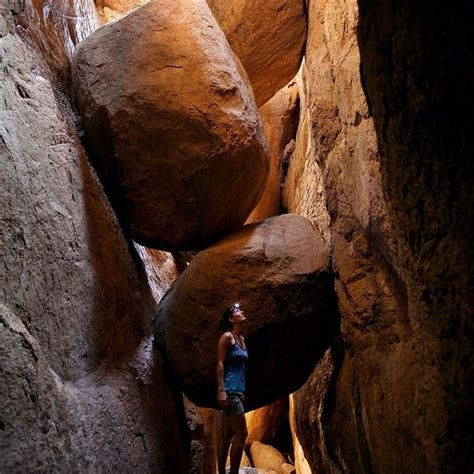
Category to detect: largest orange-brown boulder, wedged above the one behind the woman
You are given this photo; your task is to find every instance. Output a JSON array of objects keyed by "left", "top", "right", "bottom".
[{"left": 73, "top": 0, "right": 268, "bottom": 250}]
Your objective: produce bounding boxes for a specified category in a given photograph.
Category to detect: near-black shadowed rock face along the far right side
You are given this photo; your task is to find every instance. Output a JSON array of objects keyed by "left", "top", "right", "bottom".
[{"left": 358, "top": 0, "right": 474, "bottom": 472}]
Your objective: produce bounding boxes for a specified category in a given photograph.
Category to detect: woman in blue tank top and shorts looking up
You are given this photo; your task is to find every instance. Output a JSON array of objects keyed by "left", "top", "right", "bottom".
[{"left": 217, "top": 303, "right": 248, "bottom": 474}]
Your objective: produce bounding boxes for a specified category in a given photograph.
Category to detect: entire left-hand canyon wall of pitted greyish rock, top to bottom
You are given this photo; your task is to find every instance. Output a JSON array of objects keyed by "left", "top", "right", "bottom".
[{"left": 0, "top": 1, "right": 190, "bottom": 472}]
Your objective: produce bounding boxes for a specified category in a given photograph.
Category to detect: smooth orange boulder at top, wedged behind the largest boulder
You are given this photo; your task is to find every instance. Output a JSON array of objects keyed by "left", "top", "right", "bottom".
[{"left": 208, "top": 0, "right": 306, "bottom": 106}]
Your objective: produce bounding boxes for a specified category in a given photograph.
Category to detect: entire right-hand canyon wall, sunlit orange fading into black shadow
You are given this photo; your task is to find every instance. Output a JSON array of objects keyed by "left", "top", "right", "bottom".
[{"left": 285, "top": 0, "right": 473, "bottom": 472}]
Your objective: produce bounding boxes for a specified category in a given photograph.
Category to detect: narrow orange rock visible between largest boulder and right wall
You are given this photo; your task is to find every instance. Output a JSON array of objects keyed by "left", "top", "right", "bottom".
[{"left": 246, "top": 81, "right": 299, "bottom": 224}]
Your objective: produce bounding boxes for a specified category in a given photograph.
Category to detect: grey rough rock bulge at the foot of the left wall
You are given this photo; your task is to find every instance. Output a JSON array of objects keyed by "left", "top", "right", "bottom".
[{"left": 0, "top": 306, "right": 191, "bottom": 472}]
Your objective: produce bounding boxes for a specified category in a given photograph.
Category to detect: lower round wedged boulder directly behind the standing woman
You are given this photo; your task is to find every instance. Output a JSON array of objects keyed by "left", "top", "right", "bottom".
[{"left": 155, "top": 214, "right": 337, "bottom": 410}]
